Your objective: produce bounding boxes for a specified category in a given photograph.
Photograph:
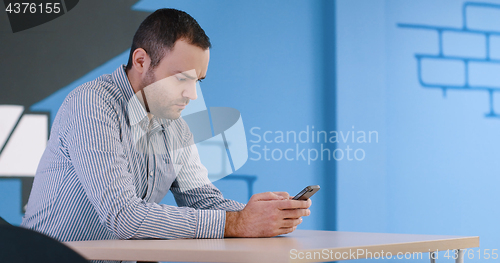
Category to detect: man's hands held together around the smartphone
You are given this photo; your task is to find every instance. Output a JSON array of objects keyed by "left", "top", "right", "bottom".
[{"left": 224, "top": 192, "right": 311, "bottom": 237}]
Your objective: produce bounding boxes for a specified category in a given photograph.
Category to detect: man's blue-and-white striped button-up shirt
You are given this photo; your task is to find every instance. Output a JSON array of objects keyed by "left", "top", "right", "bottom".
[{"left": 21, "top": 65, "right": 244, "bottom": 255}]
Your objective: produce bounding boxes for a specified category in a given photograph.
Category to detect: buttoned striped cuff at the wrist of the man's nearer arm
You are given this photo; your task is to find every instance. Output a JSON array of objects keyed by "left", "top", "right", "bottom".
[{"left": 195, "top": 210, "right": 226, "bottom": 238}]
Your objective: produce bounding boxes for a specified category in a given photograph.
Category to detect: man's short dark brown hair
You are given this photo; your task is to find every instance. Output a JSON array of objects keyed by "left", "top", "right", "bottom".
[{"left": 127, "top": 8, "right": 212, "bottom": 70}]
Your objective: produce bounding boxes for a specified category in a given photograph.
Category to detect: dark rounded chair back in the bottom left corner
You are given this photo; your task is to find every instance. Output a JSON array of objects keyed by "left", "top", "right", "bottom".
[{"left": 0, "top": 225, "right": 89, "bottom": 263}]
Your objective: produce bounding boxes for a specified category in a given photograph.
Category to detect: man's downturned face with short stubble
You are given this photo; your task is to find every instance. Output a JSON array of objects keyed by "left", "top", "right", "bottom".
[{"left": 137, "top": 39, "right": 210, "bottom": 119}]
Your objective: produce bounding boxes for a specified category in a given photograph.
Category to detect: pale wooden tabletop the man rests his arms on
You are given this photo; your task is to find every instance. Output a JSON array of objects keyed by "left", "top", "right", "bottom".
[{"left": 65, "top": 230, "right": 479, "bottom": 263}]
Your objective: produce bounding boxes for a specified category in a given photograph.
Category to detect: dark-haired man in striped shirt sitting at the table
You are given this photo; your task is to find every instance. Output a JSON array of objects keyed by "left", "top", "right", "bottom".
[{"left": 22, "top": 9, "right": 311, "bottom": 248}]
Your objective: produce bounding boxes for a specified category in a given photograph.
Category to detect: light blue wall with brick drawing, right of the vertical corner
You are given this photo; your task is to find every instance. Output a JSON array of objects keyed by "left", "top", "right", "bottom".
[{"left": 337, "top": 0, "right": 500, "bottom": 262}]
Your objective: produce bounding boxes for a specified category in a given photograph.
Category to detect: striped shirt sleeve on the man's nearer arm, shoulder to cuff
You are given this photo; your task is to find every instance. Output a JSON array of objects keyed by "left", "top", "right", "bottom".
[{"left": 61, "top": 89, "right": 235, "bottom": 239}]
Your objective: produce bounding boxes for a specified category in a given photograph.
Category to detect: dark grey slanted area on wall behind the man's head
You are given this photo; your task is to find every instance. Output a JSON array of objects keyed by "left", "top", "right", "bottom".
[{"left": 0, "top": 0, "right": 149, "bottom": 108}]
